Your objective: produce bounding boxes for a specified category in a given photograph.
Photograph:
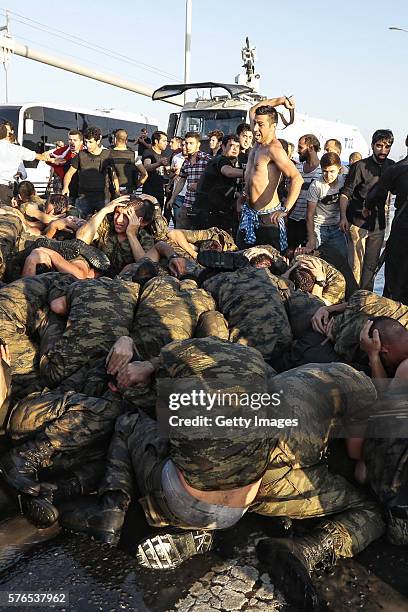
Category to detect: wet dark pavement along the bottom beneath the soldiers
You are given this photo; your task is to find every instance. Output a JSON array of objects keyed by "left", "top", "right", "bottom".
[{"left": 0, "top": 504, "right": 408, "bottom": 612}]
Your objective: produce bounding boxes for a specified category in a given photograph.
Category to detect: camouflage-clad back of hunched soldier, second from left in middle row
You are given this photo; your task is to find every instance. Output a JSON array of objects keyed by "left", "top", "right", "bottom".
[{"left": 40, "top": 277, "right": 139, "bottom": 387}]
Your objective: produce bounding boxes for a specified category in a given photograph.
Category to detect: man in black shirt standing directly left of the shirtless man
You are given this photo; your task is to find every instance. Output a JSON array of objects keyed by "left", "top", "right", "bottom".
[{"left": 193, "top": 134, "right": 244, "bottom": 233}]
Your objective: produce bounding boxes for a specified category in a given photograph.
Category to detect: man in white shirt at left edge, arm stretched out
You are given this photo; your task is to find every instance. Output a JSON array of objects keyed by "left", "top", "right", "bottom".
[{"left": 0, "top": 123, "right": 49, "bottom": 207}]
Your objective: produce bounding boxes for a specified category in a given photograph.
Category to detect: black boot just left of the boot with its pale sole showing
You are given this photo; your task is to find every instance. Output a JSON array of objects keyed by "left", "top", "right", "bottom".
[{"left": 60, "top": 491, "right": 130, "bottom": 545}]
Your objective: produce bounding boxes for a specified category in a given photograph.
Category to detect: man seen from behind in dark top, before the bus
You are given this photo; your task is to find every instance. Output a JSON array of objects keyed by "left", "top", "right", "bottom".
[{"left": 111, "top": 130, "right": 148, "bottom": 195}]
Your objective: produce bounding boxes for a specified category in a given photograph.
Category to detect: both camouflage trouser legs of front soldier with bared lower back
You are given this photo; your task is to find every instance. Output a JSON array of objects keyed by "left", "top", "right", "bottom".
[{"left": 99, "top": 413, "right": 384, "bottom": 557}]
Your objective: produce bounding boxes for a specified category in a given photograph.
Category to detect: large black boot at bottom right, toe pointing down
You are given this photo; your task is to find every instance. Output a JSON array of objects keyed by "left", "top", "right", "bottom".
[{"left": 257, "top": 529, "right": 336, "bottom": 612}]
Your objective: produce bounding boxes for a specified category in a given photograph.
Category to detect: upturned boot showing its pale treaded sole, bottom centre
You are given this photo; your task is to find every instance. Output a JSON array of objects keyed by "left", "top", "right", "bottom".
[{"left": 136, "top": 529, "right": 213, "bottom": 570}]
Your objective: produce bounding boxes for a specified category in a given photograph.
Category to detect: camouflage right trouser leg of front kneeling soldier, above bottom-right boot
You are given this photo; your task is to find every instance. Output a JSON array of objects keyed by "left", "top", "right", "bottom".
[{"left": 251, "top": 446, "right": 385, "bottom": 557}]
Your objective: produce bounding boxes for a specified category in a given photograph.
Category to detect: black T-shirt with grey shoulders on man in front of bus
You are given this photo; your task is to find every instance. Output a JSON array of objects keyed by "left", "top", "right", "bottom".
[{"left": 71, "top": 149, "right": 112, "bottom": 200}]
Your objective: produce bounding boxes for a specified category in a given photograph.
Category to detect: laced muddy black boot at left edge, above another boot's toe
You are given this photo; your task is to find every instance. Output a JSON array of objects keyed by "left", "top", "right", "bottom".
[{"left": 0, "top": 436, "right": 54, "bottom": 495}]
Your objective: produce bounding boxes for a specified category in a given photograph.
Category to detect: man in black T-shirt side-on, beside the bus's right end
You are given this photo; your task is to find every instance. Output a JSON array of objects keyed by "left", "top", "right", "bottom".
[{"left": 142, "top": 131, "right": 169, "bottom": 209}]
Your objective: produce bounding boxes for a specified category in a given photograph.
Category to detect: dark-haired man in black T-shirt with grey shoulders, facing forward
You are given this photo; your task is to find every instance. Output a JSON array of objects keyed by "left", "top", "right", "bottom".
[{"left": 62, "top": 127, "right": 119, "bottom": 218}]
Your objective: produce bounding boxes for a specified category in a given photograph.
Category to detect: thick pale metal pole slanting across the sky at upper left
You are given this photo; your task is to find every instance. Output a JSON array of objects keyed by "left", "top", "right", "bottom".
[{"left": 0, "top": 36, "right": 182, "bottom": 106}]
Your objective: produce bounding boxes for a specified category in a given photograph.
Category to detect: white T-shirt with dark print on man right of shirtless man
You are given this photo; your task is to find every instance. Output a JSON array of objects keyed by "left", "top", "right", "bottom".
[{"left": 307, "top": 174, "right": 344, "bottom": 226}]
